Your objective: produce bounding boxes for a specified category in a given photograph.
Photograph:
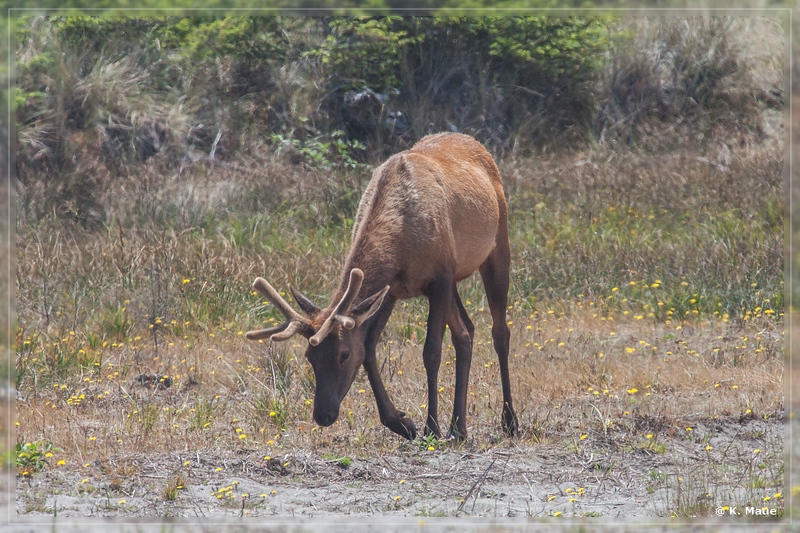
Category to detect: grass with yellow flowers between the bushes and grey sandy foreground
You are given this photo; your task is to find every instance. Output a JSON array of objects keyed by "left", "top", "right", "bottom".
[{"left": 15, "top": 132, "right": 784, "bottom": 516}]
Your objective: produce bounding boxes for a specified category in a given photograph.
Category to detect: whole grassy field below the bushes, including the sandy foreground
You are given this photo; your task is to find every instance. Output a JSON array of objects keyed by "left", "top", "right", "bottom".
[{"left": 14, "top": 131, "right": 784, "bottom": 517}]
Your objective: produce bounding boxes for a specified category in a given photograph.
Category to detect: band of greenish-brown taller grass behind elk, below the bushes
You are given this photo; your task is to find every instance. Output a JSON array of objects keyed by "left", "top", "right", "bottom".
[{"left": 16, "top": 137, "right": 784, "bottom": 388}]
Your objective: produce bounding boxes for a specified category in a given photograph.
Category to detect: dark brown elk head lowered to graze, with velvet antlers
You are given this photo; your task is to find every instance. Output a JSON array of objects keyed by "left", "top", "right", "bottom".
[{"left": 246, "top": 268, "right": 389, "bottom": 426}]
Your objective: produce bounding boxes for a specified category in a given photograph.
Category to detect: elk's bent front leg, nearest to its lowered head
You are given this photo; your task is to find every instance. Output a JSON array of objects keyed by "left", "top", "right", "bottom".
[{"left": 364, "top": 296, "right": 417, "bottom": 440}]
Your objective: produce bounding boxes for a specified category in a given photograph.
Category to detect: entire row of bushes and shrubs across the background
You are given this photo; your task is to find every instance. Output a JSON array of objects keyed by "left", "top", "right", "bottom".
[{"left": 14, "top": 16, "right": 783, "bottom": 226}]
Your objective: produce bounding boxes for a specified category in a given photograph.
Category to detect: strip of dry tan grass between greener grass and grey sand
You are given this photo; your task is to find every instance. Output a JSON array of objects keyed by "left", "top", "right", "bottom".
[{"left": 18, "top": 296, "right": 783, "bottom": 454}]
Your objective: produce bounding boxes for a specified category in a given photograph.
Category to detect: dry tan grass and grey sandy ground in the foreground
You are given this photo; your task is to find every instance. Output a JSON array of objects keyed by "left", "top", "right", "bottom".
[{"left": 16, "top": 294, "right": 783, "bottom": 516}]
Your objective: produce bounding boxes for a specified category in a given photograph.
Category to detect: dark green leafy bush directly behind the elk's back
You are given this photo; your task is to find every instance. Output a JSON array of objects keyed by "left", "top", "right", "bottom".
[{"left": 307, "top": 17, "right": 608, "bottom": 155}]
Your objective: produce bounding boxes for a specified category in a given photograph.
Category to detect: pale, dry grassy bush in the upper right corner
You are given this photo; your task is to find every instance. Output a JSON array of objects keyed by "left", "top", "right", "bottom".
[{"left": 595, "top": 17, "right": 783, "bottom": 149}]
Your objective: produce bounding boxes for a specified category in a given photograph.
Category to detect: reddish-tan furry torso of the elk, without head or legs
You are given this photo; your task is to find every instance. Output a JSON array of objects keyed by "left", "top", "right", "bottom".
[{"left": 345, "top": 133, "right": 506, "bottom": 299}]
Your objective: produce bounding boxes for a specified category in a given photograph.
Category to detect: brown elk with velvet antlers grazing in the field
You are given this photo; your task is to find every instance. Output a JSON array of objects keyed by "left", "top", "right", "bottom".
[{"left": 246, "top": 133, "right": 519, "bottom": 440}]
